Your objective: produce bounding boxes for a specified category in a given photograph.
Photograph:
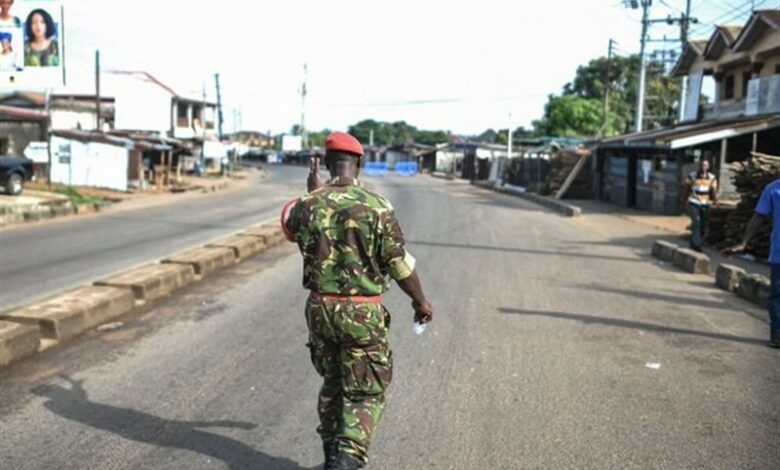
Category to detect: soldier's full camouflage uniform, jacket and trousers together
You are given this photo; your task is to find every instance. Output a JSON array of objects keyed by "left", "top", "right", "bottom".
[{"left": 286, "top": 178, "right": 414, "bottom": 464}]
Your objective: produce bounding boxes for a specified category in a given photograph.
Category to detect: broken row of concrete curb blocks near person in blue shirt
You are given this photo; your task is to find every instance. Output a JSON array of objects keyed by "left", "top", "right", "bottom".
[{"left": 652, "top": 240, "right": 770, "bottom": 320}]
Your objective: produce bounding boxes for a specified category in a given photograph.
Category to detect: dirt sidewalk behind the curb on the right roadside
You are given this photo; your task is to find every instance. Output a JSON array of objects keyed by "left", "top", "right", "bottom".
[{"left": 567, "top": 199, "right": 770, "bottom": 276}]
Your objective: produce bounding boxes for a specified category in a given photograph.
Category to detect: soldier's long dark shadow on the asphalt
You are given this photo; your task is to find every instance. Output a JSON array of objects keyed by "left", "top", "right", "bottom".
[{"left": 32, "top": 377, "right": 318, "bottom": 470}]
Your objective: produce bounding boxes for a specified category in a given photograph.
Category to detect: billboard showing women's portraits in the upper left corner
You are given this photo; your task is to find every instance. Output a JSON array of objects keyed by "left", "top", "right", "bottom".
[{"left": 0, "top": 0, "right": 65, "bottom": 89}]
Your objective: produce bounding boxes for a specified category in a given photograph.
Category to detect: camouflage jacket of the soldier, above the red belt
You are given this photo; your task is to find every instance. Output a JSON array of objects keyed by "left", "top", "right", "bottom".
[{"left": 286, "top": 177, "right": 414, "bottom": 295}]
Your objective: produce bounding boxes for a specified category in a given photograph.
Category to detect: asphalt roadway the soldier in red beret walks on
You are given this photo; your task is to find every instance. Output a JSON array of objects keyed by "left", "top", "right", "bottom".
[{"left": 0, "top": 177, "right": 780, "bottom": 470}]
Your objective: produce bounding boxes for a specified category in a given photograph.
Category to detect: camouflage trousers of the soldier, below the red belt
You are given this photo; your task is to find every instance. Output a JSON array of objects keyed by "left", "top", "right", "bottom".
[{"left": 306, "top": 298, "right": 393, "bottom": 464}]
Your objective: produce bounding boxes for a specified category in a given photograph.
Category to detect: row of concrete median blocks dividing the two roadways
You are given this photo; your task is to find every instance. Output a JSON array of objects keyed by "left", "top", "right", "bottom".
[{"left": 0, "top": 224, "right": 284, "bottom": 367}]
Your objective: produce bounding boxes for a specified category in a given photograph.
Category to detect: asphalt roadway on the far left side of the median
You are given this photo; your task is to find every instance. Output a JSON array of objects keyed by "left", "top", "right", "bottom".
[{"left": 0, "top": 166, "right": 307, "bottom": 310}]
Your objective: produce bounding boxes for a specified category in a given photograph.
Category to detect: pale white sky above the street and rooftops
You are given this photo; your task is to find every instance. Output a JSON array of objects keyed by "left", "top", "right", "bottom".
[{"left": 51, "top": 0, "right": 776, "bottom": 134}]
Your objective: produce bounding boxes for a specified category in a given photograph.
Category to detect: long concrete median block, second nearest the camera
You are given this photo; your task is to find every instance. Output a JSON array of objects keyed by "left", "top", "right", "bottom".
[{"left": 0, "top": 286, "right": 135, "bottom": 341}]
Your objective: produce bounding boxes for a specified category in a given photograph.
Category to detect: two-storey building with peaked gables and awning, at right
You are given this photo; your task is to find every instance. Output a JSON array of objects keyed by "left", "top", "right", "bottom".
[{"left": 594, "top": 10, "right": 780, "bottom": 214}]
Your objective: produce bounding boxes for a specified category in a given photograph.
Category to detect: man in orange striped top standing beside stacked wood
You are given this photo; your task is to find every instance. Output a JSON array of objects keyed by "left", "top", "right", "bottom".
[{"left": 685, "top": 160, "right": 718, "bottom": 251}]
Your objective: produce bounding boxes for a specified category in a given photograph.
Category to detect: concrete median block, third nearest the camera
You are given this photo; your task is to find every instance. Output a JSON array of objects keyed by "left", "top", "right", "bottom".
[{"left": 95, "top": 264, "right": 195, "bottom": 302}]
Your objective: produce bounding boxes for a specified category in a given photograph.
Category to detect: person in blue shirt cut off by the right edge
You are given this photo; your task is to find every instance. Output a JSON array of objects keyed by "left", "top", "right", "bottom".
[{"left": 726, "top": 178, "right": 780, "bottom": 348}]
